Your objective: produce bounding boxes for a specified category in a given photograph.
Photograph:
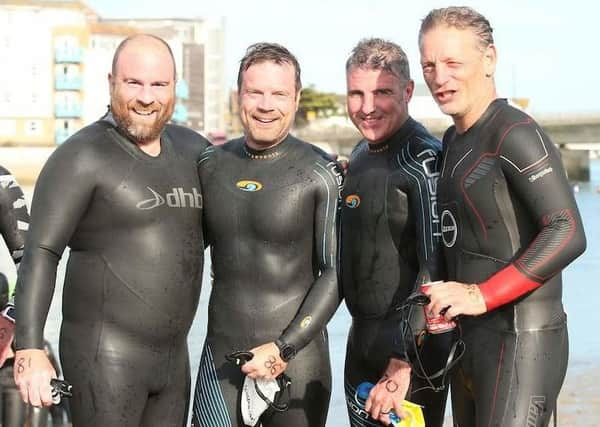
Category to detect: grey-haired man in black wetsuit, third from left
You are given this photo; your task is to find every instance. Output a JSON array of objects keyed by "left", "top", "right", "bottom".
[{"left": 340, "top": 39, "right": 446, "bottom": 427}]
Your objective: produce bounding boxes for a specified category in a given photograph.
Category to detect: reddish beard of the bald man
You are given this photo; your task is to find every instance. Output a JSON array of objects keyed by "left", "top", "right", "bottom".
[{"left": 111, "top": 99, "right": 175, "bottom": 143}]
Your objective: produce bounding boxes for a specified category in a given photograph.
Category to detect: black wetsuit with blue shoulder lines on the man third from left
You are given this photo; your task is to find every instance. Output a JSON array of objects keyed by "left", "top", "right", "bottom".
[{"left": 340, "top": 118, "right": 447, "bottom": 426}]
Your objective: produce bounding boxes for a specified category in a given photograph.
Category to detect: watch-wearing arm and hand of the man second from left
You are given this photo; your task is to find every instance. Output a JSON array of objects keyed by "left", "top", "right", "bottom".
[{"left": 242, "top": 162, "right": 342, "bottom": 378}]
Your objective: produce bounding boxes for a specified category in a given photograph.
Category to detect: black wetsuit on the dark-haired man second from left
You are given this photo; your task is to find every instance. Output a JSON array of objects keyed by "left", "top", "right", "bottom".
[{"left": 193, "top": 136, "right": 341, "bottom": 427}]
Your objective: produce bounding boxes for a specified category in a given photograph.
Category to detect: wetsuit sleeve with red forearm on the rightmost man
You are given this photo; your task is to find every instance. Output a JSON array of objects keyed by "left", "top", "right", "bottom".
[{"left": 480, "top": 118, "right": 586, "bottom": 311}]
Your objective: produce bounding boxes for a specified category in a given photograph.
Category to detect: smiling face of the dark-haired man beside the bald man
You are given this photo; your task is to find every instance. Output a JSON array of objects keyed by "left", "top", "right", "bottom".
[{"left": 238, "top": 61, "right": 300, "bottom": 150}]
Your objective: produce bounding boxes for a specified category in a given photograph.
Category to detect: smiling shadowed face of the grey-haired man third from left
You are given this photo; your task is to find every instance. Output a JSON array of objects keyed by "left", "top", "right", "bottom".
[{"left": 346, "top": 67, "right": 414, "bottom": 143}]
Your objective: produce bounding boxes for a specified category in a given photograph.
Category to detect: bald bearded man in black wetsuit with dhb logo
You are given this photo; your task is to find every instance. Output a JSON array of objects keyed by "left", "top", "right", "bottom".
[{"left": 15, "top": 35, "right": 208, "bottom": 427}]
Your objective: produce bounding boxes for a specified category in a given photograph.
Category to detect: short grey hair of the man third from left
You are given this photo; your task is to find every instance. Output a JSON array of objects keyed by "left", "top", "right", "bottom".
[{"left": 346, "top": 38, "right": 410, "bottom": 81}]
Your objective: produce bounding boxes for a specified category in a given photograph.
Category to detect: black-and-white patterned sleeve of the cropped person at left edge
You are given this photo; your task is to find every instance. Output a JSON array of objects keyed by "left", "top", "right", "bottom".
[{"left": 0, "top": 166, "right": 29, "bottom": 276}]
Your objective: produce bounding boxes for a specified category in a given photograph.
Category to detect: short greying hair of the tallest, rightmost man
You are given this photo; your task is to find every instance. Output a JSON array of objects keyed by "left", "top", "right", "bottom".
[{"left": 419, "top": 6, "right": 494, "bottom": 49}]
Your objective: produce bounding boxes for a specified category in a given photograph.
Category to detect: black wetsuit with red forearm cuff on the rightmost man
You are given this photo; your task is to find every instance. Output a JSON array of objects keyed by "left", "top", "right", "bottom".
[{"left": 438, "top": 99, "right": 585, "bottom": 427}]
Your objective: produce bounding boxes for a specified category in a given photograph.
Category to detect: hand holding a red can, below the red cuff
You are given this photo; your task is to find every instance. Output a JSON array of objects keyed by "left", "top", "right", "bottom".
[{"left": 425, "top": 282, "right": 487, "bottom": 320}]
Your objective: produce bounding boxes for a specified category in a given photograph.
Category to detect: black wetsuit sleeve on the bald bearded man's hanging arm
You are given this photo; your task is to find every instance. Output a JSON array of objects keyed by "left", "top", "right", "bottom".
[{"left": 15, "top": 142, "right": 98, "bottom": 349}]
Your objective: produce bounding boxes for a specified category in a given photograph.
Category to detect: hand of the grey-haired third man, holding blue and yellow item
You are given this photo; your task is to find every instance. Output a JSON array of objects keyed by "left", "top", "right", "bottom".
[{"left": 365, "top": 358, "right": 410, "bottom": 425}]
